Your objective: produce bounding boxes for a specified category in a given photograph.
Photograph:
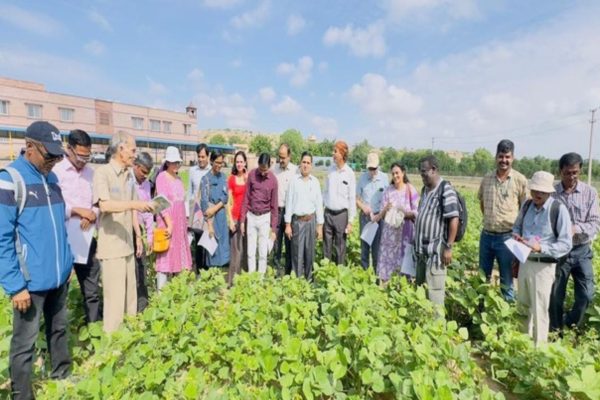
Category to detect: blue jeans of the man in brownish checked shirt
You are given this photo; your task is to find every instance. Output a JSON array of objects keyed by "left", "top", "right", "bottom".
[{"left": 479, "top": 230, "right": 515, "bottom": 301}]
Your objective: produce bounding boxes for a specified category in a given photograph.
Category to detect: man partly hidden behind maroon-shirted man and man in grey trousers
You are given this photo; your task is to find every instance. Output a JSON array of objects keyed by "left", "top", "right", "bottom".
[{"left": 273, "top": 143, "right": 298, "bottom": 275}]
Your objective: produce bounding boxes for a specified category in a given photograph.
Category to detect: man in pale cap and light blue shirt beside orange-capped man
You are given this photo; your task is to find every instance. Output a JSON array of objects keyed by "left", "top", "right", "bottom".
[{"left": 356, "top": 153, "right": 389, "bottom": 269}]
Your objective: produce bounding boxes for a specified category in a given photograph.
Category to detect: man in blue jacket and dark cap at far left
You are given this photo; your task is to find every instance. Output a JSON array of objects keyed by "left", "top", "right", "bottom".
[{"left": 0, "top": 121, "right": 73, "bottom": 399}]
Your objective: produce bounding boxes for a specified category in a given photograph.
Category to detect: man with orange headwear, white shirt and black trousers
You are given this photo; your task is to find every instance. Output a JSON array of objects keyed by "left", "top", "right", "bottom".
[{"left": 323, "top": 140, "right": 356, "bottom": 264}]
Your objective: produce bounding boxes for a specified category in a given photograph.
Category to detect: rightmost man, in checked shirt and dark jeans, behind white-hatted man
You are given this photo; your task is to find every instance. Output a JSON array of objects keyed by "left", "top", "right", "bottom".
[{"left": 550, "top": 153, "right": 600, "bottom": 330}]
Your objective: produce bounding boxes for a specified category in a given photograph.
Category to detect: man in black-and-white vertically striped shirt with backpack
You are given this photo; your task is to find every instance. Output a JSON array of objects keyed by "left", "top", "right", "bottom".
[{"left": 415, "top": 155, "right": 459, "bottom": 308}]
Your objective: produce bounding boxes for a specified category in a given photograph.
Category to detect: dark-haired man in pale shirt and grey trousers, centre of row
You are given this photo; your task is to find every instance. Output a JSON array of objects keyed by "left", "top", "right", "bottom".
[{"left": 284, "top": 151, "right": 323, "bottom": 280}]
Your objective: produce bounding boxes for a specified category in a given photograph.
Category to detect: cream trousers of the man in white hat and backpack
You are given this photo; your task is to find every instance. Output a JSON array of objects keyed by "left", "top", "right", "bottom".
[{"left": 517, "top": 261, "right": 556, "bottom": 344}]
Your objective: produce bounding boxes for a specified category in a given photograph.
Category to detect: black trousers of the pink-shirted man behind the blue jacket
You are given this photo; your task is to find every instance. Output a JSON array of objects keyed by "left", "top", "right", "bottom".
[{"left": 73, "top": 239, "right": 102, "bottom": 323}]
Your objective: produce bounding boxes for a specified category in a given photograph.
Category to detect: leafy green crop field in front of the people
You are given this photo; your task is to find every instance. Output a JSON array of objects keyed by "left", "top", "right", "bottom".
[{"left": 0, "top": 190, "right": 600, "bottom": 400}]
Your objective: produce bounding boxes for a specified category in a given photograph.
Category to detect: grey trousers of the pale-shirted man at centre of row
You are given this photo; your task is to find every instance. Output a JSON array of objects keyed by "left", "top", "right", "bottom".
[{"left": 291, "top": 216, "right": 316, "bottom": 280}]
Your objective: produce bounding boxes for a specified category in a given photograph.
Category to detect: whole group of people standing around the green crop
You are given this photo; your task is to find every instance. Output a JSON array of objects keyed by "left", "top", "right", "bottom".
[{"left": 0, "top": 121, "right": 600, "bottom": 399}]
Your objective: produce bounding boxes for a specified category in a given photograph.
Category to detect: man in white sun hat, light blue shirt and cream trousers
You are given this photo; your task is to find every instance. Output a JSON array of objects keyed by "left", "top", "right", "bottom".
[{"left": 513, "top": 171, "right": 572, "bottom": 344}]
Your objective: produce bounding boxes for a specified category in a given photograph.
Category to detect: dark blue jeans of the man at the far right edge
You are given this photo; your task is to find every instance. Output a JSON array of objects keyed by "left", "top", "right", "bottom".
[{"left": 550, "top": 244, "right": 595, "bottom": 330}]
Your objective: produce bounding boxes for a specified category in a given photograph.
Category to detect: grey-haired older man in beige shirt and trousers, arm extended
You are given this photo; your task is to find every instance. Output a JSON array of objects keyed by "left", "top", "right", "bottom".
[{"left": 93, "top": 132, "right": 153, "bottom": 333}]
